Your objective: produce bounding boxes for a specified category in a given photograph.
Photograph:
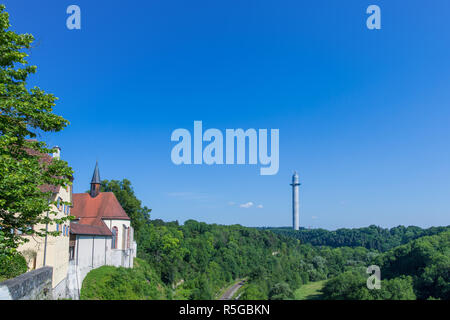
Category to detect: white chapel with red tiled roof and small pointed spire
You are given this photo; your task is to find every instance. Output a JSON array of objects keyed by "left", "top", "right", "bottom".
[{"left": 67, "top": 164, "right": 137, "bottom": 299}]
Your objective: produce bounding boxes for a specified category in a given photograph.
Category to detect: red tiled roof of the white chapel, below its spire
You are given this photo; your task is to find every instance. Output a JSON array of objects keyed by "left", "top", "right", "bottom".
[{"left": 70, "top": 192, "right": 130, "bottom": 235}]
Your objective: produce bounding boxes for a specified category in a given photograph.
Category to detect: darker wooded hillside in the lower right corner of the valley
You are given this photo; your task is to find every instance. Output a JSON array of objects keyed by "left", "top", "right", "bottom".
[{"left": 322, "top": 231, "right": 450, "bottom": 300}]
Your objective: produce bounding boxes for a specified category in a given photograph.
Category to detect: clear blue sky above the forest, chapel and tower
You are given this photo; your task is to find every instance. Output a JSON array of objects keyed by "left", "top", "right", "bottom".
[{"left": 4, "top": 0, "right": 450, "bottom": 229}]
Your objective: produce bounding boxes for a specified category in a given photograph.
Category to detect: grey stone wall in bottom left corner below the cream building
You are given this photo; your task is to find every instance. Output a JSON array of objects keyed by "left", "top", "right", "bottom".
[{"left": 0, "top": 267, "right": 53, "bottom": 300}]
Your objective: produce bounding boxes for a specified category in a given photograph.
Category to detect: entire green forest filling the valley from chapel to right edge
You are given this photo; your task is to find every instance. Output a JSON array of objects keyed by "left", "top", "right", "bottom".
[{"left": 81, "top": 180, "right": 450, "bottom": 299}]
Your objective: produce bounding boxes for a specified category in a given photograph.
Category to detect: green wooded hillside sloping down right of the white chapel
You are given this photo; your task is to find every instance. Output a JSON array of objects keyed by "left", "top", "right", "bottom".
[{"left": 82, "top": 220, "right": 377, "bottom": 299}]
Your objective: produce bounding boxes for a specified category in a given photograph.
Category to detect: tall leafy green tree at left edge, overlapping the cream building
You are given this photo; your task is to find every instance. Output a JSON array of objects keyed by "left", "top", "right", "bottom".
[{"left": 0, "top": 5, "right": 72, "bottom": 258}]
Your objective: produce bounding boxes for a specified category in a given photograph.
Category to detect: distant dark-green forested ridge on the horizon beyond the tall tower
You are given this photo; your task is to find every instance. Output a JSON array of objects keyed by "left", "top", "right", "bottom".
[{"left": 259, "top": 225, "right": 450, "bottom": 252}]
